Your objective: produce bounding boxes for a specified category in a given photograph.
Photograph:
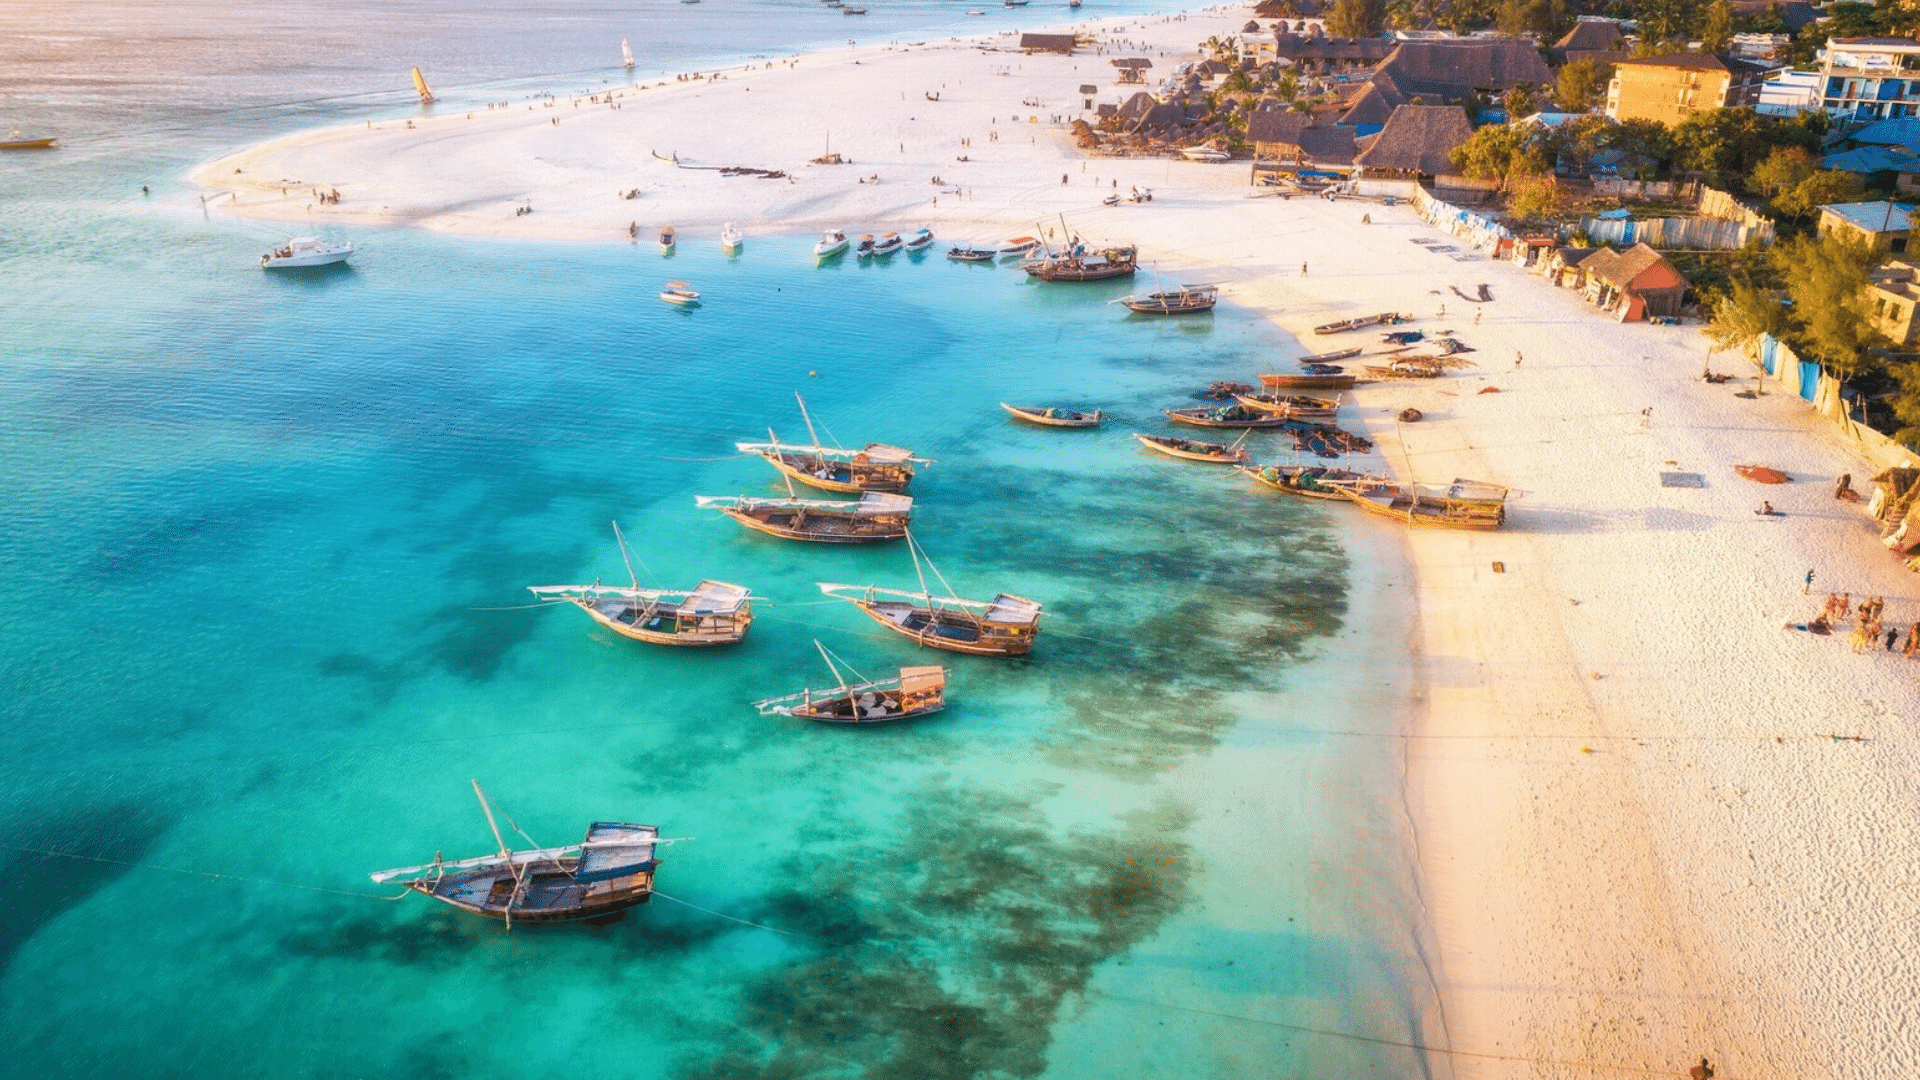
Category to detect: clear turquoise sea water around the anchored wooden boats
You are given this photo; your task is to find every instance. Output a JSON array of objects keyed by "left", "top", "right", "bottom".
[{"left": 0, "top": 0, "right": 1432, "bottom": 1078}]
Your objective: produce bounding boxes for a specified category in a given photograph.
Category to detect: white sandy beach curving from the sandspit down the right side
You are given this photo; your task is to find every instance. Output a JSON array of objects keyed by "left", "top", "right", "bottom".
[{"left": 198, "top": 8, "right": 1920, "bottom": 1080}]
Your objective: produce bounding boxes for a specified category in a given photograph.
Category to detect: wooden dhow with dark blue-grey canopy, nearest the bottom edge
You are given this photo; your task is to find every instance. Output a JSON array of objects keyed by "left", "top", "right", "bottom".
[{"left": 372, "top": 780, "right": 672, "bottom": 930}]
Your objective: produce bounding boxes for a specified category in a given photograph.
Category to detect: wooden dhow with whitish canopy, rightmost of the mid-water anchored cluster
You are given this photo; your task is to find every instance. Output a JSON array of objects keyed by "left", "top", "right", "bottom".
[{"left": 816, "top": 536, "right": 1041, "bottom": 657}]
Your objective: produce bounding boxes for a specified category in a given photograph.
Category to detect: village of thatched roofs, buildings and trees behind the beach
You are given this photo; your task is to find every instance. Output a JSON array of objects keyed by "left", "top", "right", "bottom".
[{"left": 1067, "top": 0, "right": 1920, "bottom": 588}]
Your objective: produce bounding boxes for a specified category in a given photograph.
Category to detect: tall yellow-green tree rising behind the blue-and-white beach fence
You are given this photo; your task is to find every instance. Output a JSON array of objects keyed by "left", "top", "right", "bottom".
[{"left": 1772, "top": 236, "right": 1885, "bottom": 379}]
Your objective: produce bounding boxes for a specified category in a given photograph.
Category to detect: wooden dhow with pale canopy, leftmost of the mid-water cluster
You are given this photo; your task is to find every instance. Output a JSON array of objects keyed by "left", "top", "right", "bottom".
[{"left": 526, "top": 521, "right": 753, "bottom": 646}]
